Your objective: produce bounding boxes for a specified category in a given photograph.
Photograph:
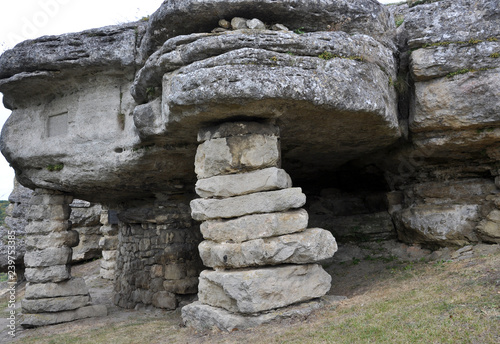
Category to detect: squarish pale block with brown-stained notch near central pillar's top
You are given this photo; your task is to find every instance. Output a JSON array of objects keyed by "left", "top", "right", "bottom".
[{"left": 195, "top": 134, "right": 280, "bottom": 179}]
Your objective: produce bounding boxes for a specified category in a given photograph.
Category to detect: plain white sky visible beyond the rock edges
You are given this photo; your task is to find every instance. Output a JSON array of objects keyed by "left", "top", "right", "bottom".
[{"left": 0, "top": 0, "right": 397, "bottom": 200}]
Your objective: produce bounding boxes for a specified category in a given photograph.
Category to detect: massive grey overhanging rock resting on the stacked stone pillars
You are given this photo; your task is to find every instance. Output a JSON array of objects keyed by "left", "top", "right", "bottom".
[{"left": 0, "top": 0, "right": 400, "bottom": 203}]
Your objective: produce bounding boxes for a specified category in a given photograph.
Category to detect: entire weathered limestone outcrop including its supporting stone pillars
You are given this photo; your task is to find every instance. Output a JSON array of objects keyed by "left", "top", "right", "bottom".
[{"left": 0, "top": 0, "right": 500, "bottom": 330}]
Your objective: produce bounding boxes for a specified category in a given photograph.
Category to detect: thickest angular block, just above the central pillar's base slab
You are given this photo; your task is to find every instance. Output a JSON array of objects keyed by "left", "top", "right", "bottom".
[{"left": 198, "top": 264, "right": 332, "bottom": 313}]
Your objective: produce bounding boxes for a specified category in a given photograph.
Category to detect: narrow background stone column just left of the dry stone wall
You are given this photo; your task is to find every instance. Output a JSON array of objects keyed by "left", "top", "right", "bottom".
[{"left": 99, "top": 210, "right": 118, "bottom": 280}]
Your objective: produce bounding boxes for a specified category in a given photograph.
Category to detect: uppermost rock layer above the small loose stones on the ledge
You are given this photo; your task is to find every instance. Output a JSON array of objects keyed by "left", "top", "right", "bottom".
[{"left": 142, "top": 0, "right": 394, "bottom": 56}]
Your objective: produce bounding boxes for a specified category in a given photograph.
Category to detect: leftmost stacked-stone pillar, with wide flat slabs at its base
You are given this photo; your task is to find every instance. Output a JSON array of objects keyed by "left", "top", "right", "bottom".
[{"left": 22, "top": 189, "right": 107, "bottom": 327}]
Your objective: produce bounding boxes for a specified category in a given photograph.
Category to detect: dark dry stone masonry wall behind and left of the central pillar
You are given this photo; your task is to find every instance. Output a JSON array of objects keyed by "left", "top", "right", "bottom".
[{"left": 114, "top": 196, "right": 202, "bottom": 309}]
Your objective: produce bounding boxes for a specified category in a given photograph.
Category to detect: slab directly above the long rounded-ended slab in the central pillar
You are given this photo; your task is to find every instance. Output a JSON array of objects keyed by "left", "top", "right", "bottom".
[{"left": 200, "top": 209, "right": 309, "bottom": 243}]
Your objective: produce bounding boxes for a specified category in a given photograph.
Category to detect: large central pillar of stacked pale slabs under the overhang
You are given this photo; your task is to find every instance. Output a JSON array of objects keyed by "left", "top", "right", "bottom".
[{"left": 182, "top": 122, "right": 337, "bottom": 330}]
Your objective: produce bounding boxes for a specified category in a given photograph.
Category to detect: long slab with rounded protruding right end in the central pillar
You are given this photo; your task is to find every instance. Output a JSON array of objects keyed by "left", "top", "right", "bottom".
[{"left": 198, "top": 228, "right": 337, "bottom": 268}]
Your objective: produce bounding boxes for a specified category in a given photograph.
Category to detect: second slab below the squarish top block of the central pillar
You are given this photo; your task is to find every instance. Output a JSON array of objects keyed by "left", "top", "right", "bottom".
[{"left": 190, "top": 188, "right": 306, "bottom": 221}]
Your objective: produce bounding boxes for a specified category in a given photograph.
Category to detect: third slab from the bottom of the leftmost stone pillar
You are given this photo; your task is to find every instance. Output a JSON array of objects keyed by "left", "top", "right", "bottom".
[{"left": 24, "top": 278, "right": 89, "bottom": 300}]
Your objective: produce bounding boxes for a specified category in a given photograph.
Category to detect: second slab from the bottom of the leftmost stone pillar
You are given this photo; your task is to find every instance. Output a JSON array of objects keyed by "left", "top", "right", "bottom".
[{"left": 21, "top": 295, "right": 90, "bottom": 313}]
